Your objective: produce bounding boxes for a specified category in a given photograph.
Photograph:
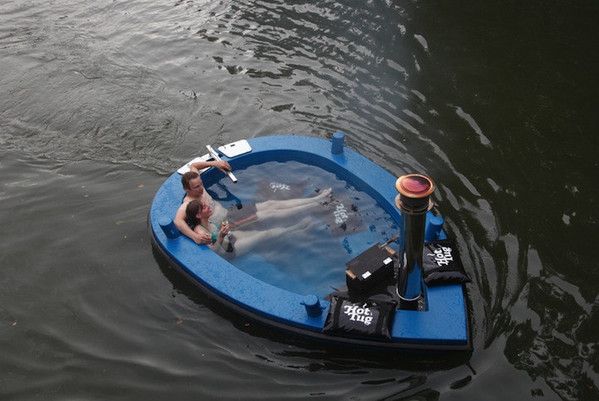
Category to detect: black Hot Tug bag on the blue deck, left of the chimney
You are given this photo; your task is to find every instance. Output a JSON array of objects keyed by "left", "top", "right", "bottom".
[{"left": 324, "top": 296, "right": 395, "bottom": 340}]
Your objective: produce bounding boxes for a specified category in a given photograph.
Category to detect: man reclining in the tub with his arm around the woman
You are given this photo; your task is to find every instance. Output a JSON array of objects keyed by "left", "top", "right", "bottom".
[{"left": 174, "top": 161, "right": 331, "bottom": 244}]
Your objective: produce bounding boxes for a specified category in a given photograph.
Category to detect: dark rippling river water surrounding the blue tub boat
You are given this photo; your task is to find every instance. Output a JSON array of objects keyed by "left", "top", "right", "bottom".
[{"left": 0, "top": 0, "right": 599, "bottom": 400}]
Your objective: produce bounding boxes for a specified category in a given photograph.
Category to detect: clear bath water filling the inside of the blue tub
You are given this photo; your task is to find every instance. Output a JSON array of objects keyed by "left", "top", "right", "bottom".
[{"left": 206, "top": 161, "right": 399, "bottom": 297}]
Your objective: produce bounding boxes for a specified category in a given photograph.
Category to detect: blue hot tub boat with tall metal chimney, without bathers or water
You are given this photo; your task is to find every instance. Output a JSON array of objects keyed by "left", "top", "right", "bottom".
[{"left": 148, "top": 132, "right": 471, "bottom": 351}]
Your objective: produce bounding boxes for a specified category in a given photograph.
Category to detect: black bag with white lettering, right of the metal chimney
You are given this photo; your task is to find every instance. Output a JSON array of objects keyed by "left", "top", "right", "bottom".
[{"left": 422, "top": 240, "right": 470, "bottom": 285}]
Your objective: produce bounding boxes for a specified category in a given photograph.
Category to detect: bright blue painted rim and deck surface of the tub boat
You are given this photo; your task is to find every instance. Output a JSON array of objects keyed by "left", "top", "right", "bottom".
[{"left": 149, "top": 135, "right": 469, "bottom": 348}]
